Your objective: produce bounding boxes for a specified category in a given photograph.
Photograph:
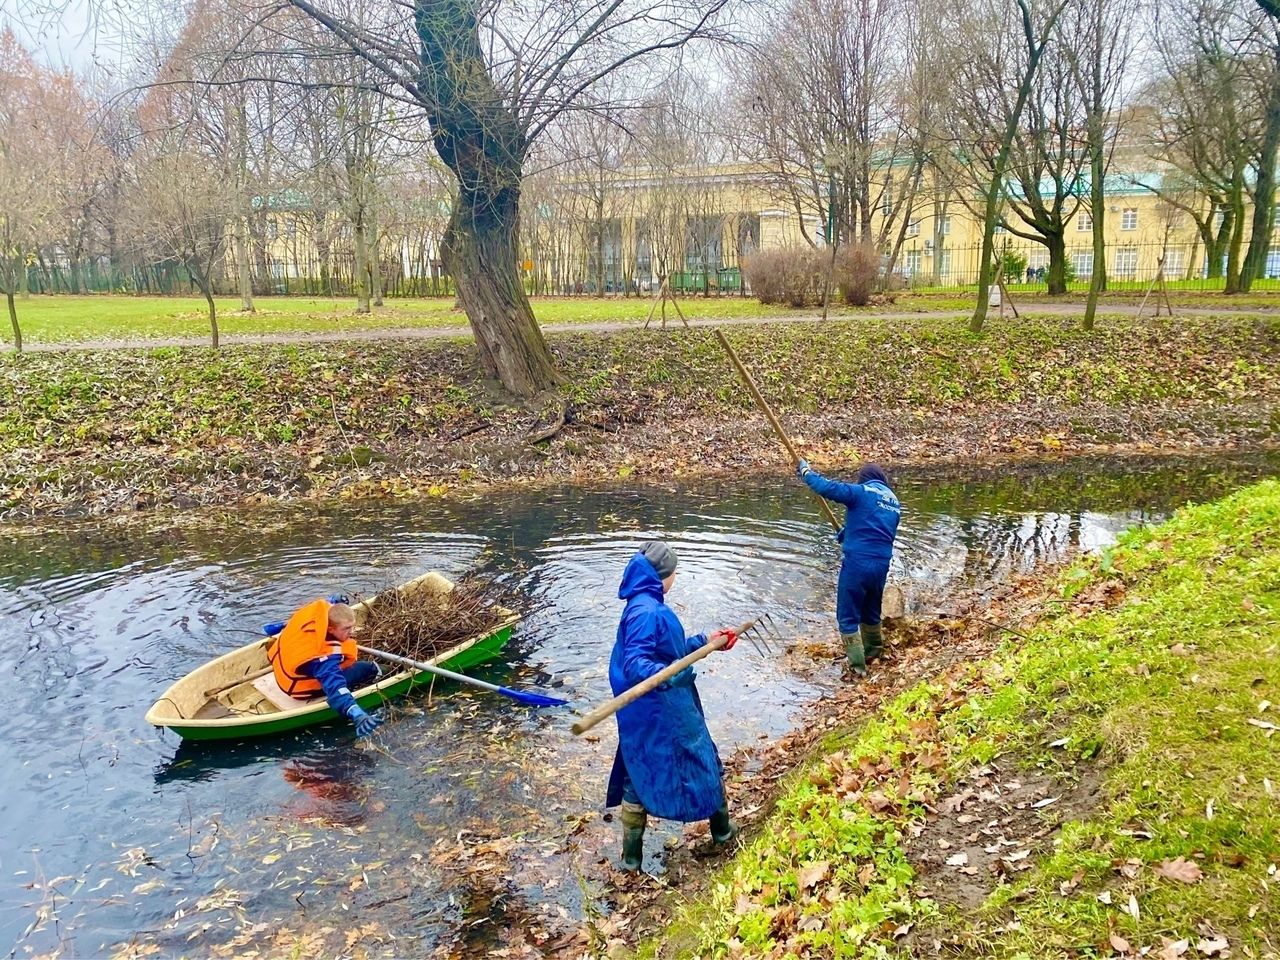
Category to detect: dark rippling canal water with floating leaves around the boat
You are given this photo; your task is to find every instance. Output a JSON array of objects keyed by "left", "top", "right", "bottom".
[{"left": 0, "top": 456, "right": 1280, "bottom": 956}]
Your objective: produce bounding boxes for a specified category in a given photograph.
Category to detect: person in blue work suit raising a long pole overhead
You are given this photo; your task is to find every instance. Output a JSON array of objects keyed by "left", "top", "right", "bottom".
[{"left": 796, "top": 460, "right": 902, "bottom": 676}]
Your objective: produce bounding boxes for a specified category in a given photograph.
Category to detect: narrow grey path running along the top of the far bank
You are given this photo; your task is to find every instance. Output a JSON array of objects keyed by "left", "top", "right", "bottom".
[{"left": 4, "top": 303, "right": 1276, "bottom": 353}]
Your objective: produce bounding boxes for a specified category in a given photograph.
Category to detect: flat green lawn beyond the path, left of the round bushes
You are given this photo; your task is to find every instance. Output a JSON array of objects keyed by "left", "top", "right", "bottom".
[{"left": 0, "top": 296, "right": 786, "bottom": 343}]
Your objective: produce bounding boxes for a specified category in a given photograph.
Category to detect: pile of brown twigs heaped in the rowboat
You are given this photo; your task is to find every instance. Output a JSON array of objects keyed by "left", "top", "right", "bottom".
[{"left": 356, "top": 576, "right": 526, "bottom": 660}]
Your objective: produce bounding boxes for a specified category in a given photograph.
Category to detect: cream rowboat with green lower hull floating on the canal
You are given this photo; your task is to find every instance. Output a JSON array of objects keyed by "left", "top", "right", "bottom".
[{"left": 146, "top": 572, "right": 520, "bottom": 740}]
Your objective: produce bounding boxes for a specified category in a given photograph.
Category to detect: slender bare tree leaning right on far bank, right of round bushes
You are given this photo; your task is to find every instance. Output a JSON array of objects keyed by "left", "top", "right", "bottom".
[{"left": 942, "top": 0, "right": 1068, "bottom": 333}]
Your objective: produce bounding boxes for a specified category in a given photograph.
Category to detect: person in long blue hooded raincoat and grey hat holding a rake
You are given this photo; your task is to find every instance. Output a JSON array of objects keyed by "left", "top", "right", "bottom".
[{"left": 605, "top": 541, "right": 737, "bottom": 870}]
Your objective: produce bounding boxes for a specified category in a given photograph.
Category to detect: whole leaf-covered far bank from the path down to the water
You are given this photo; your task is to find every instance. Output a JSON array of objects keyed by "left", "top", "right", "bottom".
[{"left": 0, "top": 316, "right": 1280, "bottom": 520}]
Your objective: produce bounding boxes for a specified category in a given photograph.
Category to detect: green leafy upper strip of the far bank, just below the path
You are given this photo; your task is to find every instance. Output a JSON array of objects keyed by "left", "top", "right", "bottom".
[{"left": 0, "top": 317, "right": 1280, "bottom": 463}]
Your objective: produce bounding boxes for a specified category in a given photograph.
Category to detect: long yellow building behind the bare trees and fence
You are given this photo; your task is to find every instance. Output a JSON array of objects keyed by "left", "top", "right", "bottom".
[{"left": 244, "top": 163, "right": 1280, "bottom": 296}]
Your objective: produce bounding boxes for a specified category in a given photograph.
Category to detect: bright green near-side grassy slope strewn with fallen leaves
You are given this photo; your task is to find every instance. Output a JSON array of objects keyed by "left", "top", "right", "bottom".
[{"left": 643, "top": 481, "right": 1280, "bottom": 957}]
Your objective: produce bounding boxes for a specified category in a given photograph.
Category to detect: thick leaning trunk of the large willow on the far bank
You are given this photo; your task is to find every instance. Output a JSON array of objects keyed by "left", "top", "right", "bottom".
[{"left": 415, "top": 0, "right": 558, "bottom": 397}]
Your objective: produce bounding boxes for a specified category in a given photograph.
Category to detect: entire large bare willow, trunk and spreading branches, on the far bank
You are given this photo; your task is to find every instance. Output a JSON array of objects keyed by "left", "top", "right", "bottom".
[{"left": 267, "top": 0, "right": 727, "bottom": 397}]
